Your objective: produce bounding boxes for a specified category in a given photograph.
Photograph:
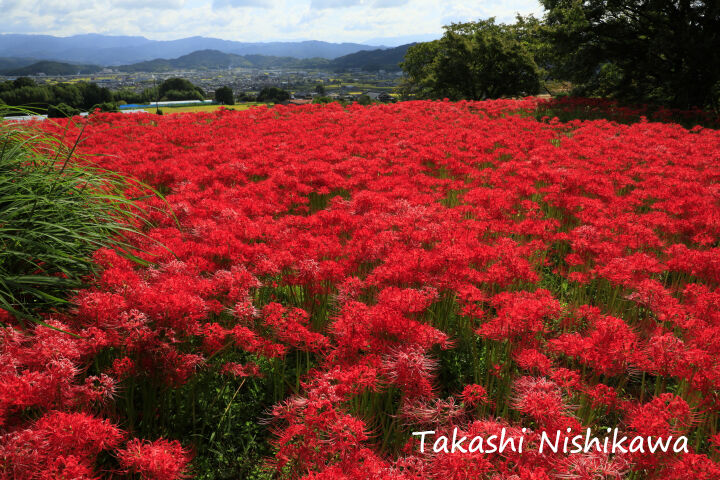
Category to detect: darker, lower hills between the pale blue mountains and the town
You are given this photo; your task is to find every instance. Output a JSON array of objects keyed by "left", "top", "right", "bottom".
[{"left": 0, "top": 44, "right": 412, "bottom": 76}]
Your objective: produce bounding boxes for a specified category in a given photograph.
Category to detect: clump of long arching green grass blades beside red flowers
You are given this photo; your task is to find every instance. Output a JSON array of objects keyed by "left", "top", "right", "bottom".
[{"left": 0, "top": 115, "right": 143, "bottom": 322}]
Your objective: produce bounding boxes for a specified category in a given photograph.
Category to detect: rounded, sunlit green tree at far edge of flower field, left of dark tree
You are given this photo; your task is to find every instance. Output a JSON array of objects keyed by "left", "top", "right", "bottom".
[{"left": 401, "top": 18, "right": 540, "bottom": 100}]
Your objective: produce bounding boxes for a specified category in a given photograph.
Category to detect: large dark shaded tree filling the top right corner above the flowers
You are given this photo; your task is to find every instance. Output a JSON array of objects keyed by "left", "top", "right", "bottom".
[{"left": 541, "top": 0, "right": 720, "bottom": 108}]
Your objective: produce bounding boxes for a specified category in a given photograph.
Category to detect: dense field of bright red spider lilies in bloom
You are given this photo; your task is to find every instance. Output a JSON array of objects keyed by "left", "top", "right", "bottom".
[{"left": 0, "top": 99, "right": 720, "bottom": 480}]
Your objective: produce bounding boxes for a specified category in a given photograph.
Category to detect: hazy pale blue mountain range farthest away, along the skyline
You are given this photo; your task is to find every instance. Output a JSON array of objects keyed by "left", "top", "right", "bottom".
[{"left": 0, "top": 34, "right": 386, "bottom": 66}]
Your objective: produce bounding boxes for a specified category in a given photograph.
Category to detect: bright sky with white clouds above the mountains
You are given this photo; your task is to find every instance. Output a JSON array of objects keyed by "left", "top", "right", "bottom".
[{"left": 0, "top": 0, "right": 542, "bottom": 42}]
